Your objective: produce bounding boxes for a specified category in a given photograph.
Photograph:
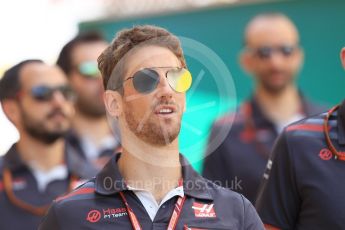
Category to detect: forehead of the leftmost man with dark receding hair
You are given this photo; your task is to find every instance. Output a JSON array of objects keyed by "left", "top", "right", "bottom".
[{"left": 20, "top": 63, "right": 67, "bottom": 89}]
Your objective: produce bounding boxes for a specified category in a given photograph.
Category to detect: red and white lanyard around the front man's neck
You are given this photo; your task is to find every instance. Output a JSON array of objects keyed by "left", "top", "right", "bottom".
[{"left": 120, "top": 192, "right": 186, "bottom": 230}]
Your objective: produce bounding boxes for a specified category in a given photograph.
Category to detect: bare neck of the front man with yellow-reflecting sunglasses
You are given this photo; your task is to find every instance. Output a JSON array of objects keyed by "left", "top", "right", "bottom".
[{"left": 118, "top": 131, "right": 182, "bottom": 203}]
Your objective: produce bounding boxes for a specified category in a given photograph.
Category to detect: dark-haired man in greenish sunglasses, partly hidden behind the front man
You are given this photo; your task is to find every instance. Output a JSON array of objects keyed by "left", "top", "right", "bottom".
[{"left": 57, "top": 32, "right": 119, "bottom": 169}]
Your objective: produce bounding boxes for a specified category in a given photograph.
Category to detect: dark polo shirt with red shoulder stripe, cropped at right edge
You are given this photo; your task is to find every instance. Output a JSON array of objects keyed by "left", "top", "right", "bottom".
[{"left": 257, "top": 99, "right": 345, "bottom": 230}]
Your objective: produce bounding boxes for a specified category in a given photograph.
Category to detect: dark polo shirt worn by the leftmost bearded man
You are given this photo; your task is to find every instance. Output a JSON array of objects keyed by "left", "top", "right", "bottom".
[{"left": 0, "top": 145, "right": 94, "bottom": 230}]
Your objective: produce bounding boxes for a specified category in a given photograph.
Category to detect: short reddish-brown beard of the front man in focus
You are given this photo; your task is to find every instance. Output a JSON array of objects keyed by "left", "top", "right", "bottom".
[{"left": 124, "top": 102, "right": 181, "bottom": 146}]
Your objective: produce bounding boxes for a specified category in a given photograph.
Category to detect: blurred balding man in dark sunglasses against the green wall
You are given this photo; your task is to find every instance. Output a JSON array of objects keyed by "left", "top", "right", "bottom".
[{"left": 203, "top": 13, "right": 323, "bottom": 204}]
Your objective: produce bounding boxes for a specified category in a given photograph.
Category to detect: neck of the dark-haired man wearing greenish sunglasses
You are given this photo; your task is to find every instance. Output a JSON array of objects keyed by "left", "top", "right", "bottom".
[{"left": 73, "top": 111, "right": 112, "bottom": 146}]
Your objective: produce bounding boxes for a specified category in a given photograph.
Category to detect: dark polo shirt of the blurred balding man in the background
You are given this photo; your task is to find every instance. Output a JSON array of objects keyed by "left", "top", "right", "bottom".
[{"left": 203, "top": 97, "right": 325, "bottom": 204}]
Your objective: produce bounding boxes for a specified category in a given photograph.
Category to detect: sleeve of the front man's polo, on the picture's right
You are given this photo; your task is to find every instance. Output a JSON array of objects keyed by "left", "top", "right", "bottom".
[{"left": 242, "top": 196, "right": 264, "bottom": 230}]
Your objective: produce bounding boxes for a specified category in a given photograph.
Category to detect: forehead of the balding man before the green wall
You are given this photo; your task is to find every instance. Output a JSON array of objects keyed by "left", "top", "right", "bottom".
[{"left": 246, "top": 18, "right": 298, "bottom": 46}]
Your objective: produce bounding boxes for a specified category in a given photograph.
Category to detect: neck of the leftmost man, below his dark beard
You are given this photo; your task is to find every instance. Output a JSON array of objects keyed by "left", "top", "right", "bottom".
[{"left": 16, "top": 134, "right": 65, "bottom": 171}]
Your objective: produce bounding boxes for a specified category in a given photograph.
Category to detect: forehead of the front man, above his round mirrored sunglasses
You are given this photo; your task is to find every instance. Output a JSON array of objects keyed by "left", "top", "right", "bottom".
[{"left": 125, "top": 46, "right": 181, "bottom": 71}]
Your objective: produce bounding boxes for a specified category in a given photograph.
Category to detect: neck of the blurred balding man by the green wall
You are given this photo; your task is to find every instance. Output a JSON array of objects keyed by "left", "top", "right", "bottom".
[{"left": 255, "top": 85, "right": 302, "bottom": 123}]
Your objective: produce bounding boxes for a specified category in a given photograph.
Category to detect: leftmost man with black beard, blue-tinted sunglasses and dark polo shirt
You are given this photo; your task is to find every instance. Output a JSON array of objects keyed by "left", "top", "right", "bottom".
[{"left": 0, "top": 60, "right": 93, "bottom": 229}]
